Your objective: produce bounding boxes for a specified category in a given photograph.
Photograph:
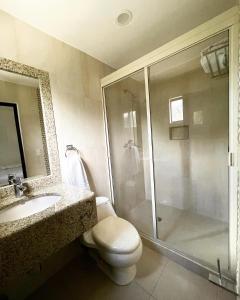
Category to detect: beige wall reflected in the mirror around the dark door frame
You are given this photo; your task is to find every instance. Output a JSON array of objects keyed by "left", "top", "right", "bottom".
[{"left": 0, "top": 81, "right": 47, "bottom": 177}]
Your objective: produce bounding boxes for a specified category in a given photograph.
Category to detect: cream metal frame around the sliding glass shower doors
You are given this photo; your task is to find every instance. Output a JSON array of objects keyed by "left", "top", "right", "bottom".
[{"left": 101, "top": 6, "right": 240, "bottom": 291}]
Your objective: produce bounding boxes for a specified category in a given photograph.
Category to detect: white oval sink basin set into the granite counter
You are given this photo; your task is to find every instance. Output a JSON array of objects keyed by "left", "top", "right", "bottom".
[{"left": 0, "top": 194, "right": 61, "bottom": 224}]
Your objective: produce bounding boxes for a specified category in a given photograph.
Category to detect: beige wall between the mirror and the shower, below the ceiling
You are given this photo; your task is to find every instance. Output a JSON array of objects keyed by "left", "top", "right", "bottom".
[{"left": 0, "top": 11, "right": 112, "bottom": 195}]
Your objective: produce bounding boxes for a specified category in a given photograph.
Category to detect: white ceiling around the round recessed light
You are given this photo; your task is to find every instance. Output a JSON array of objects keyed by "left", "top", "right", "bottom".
[{"left": 0, "top": 0, "right": 237, "bottom": 68}]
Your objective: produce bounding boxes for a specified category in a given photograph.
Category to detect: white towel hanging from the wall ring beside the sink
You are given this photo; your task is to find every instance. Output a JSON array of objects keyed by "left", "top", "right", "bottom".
[{"left": 65, "top": 150, "right": 90, "bottom": 190}]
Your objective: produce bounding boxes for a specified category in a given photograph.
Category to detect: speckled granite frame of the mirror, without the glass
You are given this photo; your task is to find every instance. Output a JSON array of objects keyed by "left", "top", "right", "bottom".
[{"left": 0, "top": 58, "right": 61, "bottom": 201}]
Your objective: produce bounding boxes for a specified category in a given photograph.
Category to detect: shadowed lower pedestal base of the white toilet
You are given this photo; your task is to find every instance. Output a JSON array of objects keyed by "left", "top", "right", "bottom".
[{"left": 89, "top": 249, "right": 136, "bottom": 285}]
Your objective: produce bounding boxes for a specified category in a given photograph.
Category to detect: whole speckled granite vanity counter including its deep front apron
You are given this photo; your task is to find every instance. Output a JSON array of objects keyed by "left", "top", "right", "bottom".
[{"left": 0, "top": 184, "right": 97, "bottom": 293}]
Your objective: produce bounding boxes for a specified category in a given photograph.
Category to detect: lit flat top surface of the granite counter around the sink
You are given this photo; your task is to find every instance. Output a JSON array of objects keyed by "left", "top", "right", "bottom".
[{"left": 0, "top": 184, "right": 94, "bottom": 239}]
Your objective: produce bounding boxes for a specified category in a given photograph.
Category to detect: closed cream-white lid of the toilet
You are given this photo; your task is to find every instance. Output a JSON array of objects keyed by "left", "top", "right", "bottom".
[{"left": 92, "top": 216, "right": 140, "bottom": 253}]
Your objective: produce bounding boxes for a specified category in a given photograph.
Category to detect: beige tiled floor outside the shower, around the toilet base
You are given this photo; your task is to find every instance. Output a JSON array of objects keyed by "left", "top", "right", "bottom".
[{"left": 28, "top": 246, "right": 235, "bottom": 300}]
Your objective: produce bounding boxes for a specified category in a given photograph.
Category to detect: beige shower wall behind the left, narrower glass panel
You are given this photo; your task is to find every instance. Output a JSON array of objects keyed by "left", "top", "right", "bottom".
[{"left": 105, "top": 79, "right": 145, "bottom": 207}]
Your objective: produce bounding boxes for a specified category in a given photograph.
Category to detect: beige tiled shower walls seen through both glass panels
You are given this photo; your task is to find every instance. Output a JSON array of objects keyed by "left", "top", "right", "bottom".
[{"left": 101, "top": 56, "right": 228, "bottom": 227}]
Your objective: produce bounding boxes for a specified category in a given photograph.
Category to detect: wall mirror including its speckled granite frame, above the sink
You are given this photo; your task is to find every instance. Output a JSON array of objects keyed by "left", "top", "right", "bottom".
[{"left": 0, "top": 58, "right": 61, "bottom": 197}]
